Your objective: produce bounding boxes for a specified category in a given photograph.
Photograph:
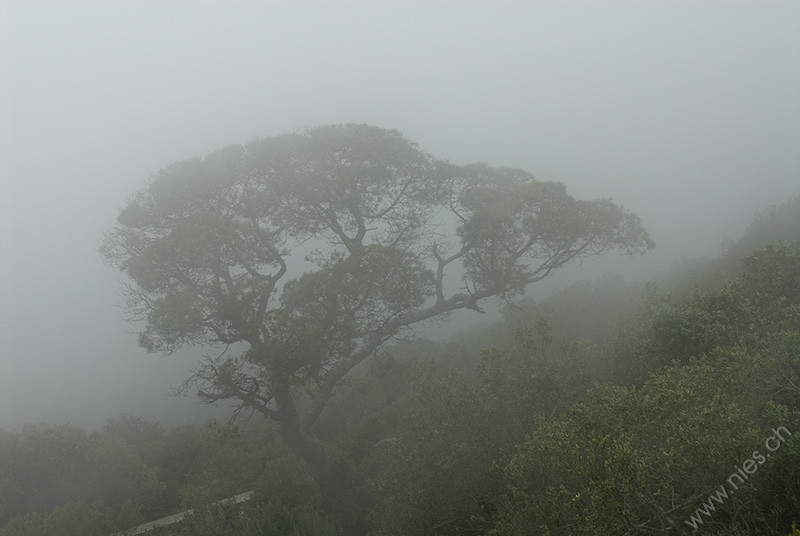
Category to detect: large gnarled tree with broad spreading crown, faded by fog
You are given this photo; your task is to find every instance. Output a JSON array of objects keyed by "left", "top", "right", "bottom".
[{"left": 101, "top": 125, "right": 653, "bottom": 504}]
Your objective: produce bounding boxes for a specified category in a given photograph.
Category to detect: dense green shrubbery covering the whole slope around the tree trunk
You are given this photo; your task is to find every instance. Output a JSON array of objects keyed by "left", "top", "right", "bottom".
[{"left": 0, "top": 205, "right": 800, "bottom": 536}]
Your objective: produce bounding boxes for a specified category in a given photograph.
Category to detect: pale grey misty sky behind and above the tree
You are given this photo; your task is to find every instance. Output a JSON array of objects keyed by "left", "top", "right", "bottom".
[{"left": 0, "top": 0, "right": 800, "bottom": 427}]
